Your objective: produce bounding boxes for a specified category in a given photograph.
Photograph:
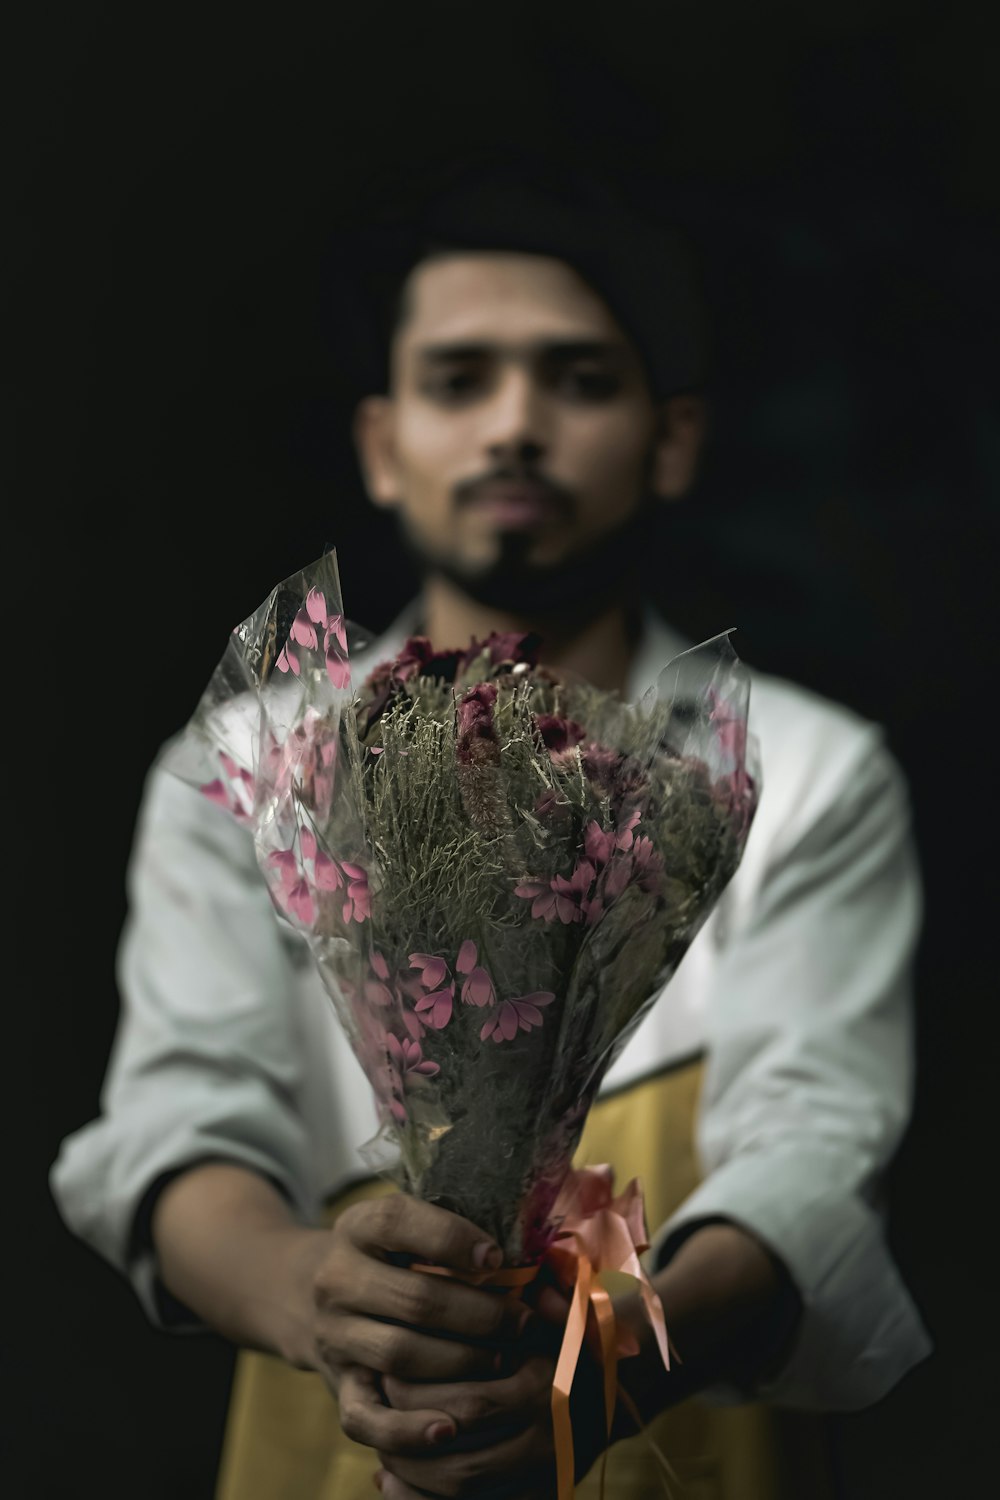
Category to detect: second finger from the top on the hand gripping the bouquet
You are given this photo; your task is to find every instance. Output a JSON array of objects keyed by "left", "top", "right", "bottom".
[{"left": 313, "top": 1253, "right": 531, "bottom": 1340}]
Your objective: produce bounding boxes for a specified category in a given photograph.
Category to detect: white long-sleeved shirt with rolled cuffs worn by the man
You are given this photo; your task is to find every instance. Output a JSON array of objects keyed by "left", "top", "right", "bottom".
[{"left": 51, "top": 594, "right": 931, "bottom": 1410}]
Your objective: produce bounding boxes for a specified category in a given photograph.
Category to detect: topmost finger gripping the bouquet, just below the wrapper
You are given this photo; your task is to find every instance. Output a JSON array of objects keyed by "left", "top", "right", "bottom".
[{"left": 339, "top": 1193, "right": 504, "bottom": 1271}]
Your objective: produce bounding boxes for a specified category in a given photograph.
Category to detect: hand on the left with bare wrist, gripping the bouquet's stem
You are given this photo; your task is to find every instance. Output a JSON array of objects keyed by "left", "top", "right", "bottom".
[{"left": 151, "top": 1163, "right": 525, "bottom": 1452}]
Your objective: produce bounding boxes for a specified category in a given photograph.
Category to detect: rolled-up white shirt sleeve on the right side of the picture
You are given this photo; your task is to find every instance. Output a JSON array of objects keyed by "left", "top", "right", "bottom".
[{"left": 654, "top": 726, "right": 931, "bottom": 1412}]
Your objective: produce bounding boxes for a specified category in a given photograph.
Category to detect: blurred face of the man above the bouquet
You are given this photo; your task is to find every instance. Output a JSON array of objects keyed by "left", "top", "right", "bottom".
[{"left": 358, "top": 252, "right": 668, "bottom": 609}]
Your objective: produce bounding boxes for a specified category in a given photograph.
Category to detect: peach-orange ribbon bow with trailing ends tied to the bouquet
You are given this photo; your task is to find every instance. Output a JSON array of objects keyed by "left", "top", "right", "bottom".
[{"left": 546, "top": 1164, "right": 670, "bottom": 1500}]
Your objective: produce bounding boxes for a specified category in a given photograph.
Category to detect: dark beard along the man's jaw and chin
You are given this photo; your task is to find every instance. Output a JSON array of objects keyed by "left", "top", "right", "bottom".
[{"left": 396, "top": 492, "right": 661, "bottom": 633}]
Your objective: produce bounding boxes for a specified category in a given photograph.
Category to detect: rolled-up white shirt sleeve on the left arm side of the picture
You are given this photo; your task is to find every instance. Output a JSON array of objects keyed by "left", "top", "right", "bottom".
[{"left": 49, "top": 767, "right": 313, "bottom": 1331}]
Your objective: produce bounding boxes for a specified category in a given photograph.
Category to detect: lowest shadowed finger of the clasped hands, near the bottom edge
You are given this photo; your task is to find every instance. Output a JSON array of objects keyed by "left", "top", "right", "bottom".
[{"left": 378, "top": 1424, "right": 553, "bottom": 1500}]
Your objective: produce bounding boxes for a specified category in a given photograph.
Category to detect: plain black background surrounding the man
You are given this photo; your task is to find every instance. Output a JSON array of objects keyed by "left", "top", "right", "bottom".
[{"left": 11, "top": 0, "right": 1000, "bottom": 1500}]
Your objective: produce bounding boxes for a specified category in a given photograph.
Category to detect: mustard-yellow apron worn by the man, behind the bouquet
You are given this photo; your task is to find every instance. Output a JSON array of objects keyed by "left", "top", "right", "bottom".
[{"left": 216, "top": 1062, "right": 834, "bottom": 1500}]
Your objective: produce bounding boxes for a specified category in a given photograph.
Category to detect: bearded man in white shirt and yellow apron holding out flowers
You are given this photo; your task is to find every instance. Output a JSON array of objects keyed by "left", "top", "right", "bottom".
[{"left": 52, "top": 158, "right": 928, "bottom": 1500}]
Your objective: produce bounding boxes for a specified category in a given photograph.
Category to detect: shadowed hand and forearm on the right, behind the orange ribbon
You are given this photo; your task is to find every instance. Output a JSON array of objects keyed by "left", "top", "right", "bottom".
[{"left": 371, "top": 1223, "right": 798, "bottom": 1500}]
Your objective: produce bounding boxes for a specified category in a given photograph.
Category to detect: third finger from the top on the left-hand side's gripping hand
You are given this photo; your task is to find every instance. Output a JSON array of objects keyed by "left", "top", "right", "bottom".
[{"left": 316, "top": 1314, "right": 502, "bottom": 1382}]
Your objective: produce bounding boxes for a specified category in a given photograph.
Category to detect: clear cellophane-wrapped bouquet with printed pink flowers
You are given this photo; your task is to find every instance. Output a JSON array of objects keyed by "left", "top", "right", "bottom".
[{"left": 166, "top": 551, "right": 760, "bottom": 1265}]
